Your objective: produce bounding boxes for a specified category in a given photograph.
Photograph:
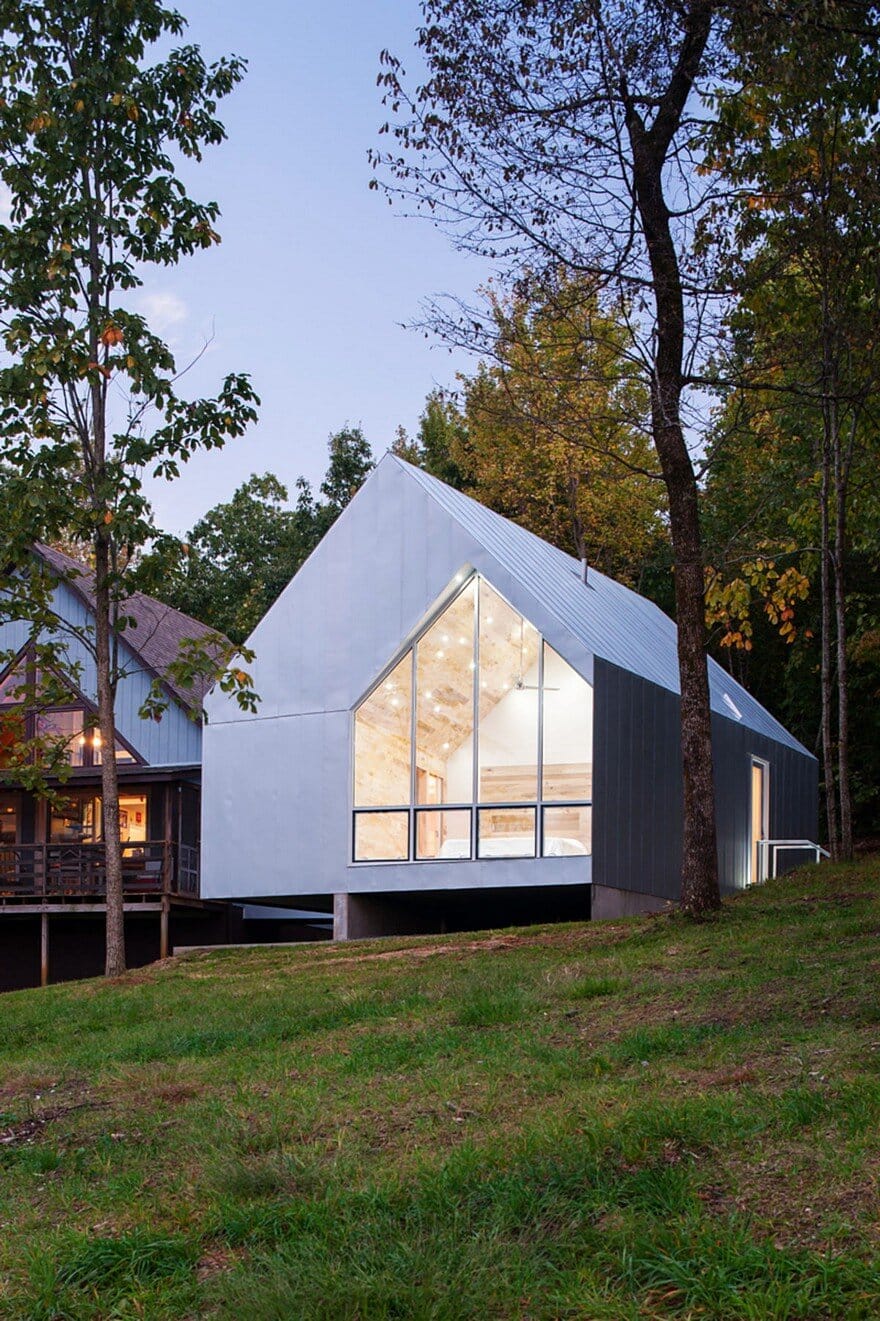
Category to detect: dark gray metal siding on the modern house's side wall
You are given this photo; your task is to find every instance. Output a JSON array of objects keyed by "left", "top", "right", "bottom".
[{"left": 593, "top": 658, "right": 818, "bottom": 900}]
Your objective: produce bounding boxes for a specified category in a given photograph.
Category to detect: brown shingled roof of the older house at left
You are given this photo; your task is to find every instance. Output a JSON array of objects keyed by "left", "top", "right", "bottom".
[{"left": 34, "top": 543, "right": 226, "bottom": 711}]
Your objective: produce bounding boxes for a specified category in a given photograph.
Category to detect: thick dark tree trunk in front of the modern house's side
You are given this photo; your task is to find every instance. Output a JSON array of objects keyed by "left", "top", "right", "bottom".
[{"left": 626, "top": 23, "right": 721, "bottom": 917}]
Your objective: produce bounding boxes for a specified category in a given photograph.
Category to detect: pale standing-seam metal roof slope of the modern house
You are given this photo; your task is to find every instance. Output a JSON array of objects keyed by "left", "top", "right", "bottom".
[{"left": 383, "top": 454, "right": 813, "bottom": 757}]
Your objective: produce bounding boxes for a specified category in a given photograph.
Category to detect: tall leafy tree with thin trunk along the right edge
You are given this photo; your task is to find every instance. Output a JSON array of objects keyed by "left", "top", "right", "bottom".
[{"left": 707, "top": 5, "right": 880, "bottom": 857}]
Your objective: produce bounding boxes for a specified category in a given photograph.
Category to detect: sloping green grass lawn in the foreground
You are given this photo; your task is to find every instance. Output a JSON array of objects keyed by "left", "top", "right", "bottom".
[{"left": 0, "top": 859, "right": 880, "bottom": 1321}]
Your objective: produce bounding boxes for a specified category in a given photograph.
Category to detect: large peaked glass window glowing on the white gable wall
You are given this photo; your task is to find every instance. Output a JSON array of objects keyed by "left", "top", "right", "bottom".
[{"left": 354, "top": 575, "right": 593, "bottom": 863}]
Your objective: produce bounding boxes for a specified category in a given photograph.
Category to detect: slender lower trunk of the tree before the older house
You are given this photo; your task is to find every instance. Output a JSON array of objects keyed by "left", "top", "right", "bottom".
[{"left": 95, "top": 534, "right": 126, "bottom": 978}]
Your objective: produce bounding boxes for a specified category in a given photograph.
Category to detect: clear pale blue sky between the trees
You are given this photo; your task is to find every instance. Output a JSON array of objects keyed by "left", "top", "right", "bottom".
[{"left": 143, "top": 0, "right": 488, "bottom": 532}]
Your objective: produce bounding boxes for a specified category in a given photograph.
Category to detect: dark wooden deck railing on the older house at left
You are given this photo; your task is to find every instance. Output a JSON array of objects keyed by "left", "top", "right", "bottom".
[{"left": 0, "top": 840, "right": 198, "bottom": 905}]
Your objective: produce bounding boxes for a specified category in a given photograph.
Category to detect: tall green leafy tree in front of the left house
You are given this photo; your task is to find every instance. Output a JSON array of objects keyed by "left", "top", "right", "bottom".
[{"left": 0, "top": 0, "right": 256, "bottom": 974}]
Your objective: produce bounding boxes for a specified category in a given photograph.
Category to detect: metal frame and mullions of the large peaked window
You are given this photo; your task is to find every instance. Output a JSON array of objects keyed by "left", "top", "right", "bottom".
[{"left": 348, "top": 569, "right": 595, "bottom": 867}]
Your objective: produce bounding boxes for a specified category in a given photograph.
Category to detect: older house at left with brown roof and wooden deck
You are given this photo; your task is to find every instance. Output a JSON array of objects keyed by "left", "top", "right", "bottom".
[{"left": 0, "top": 546, "right": 226, "bottom": 989}]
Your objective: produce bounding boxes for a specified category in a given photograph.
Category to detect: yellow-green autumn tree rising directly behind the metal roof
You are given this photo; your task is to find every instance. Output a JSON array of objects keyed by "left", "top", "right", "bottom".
[{"left": 453, "top": 276, "right": 666, "bottom": 583}]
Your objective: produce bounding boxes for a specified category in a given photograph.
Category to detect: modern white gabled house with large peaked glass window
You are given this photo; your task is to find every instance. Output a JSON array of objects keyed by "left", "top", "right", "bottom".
[{"left": 202, "top": 454, "right": 818, "bottom": 938}]
